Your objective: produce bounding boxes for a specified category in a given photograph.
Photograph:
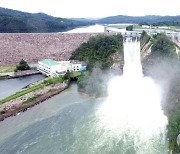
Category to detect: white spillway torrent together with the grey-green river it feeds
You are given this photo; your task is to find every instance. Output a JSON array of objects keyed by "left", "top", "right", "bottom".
[{"left": 0, "top": 40, "right": 167, "bottom": 154}]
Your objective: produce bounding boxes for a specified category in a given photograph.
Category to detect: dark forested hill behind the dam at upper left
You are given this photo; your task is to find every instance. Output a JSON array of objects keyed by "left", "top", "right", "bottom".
[{"left": 0, "top": 8, "right": 92, "bottom": 33}]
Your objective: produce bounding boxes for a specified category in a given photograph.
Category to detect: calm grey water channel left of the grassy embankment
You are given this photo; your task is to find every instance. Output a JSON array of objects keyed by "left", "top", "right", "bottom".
[{"left": 0, "top": 75, "right": 45, "bottom": 100}]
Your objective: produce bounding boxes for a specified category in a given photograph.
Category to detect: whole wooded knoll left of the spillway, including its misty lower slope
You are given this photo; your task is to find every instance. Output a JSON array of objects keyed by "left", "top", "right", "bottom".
[{"left": 70, "top": 34, "right": 124, "bottom": 97}]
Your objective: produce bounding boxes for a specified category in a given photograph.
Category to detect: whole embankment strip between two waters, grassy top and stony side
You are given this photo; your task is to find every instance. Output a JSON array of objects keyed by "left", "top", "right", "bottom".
[{"left": 0, "top": 75, "right": 70, "bottom": 121}]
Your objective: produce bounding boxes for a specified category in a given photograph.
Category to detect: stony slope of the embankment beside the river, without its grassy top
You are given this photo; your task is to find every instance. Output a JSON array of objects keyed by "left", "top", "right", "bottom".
[{"left": 0, "top": 81, "right": 70, "bottom": 121}]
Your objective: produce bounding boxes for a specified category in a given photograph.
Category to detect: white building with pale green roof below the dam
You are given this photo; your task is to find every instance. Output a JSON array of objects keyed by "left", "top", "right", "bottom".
[{"left": 38, "top": 59, "right": 87, "bottom": 77}]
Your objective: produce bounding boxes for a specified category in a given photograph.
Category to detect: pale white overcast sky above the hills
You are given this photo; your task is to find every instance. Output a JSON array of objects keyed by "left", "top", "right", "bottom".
[{"left": 0, "top": 0, "right": 180, "bottom": 18}]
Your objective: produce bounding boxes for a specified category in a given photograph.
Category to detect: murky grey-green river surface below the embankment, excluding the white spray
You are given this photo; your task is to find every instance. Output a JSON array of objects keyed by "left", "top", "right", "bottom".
[{"left": 0, "top": 84, "right": 165, "bottom": 154}]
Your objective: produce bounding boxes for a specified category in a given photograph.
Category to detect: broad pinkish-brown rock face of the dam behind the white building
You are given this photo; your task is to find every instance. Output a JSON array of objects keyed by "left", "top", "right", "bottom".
[{"left": 0, "top": 33, "right": 102, "bottom": 65}]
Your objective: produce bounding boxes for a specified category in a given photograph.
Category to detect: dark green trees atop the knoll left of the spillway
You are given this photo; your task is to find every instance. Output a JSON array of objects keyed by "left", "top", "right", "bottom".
[{"left": 70, "top": 34, "right": 123, "bottom": 69}]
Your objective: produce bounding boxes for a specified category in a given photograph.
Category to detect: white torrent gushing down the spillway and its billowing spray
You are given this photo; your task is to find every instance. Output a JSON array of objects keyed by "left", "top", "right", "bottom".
[{"left": 98, "top": 42, "right": 167, "bottom": 154}]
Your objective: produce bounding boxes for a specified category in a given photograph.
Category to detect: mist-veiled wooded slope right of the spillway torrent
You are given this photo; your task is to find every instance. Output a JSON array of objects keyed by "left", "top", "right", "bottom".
[{"left": 141, "top": 32, "right": 180, "bottom": 153}]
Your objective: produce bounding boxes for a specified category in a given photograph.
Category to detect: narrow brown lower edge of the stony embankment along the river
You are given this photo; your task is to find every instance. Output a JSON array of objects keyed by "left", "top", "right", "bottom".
[{"left": 0, "top": 81, "right": 71, "bottom": 122}]
